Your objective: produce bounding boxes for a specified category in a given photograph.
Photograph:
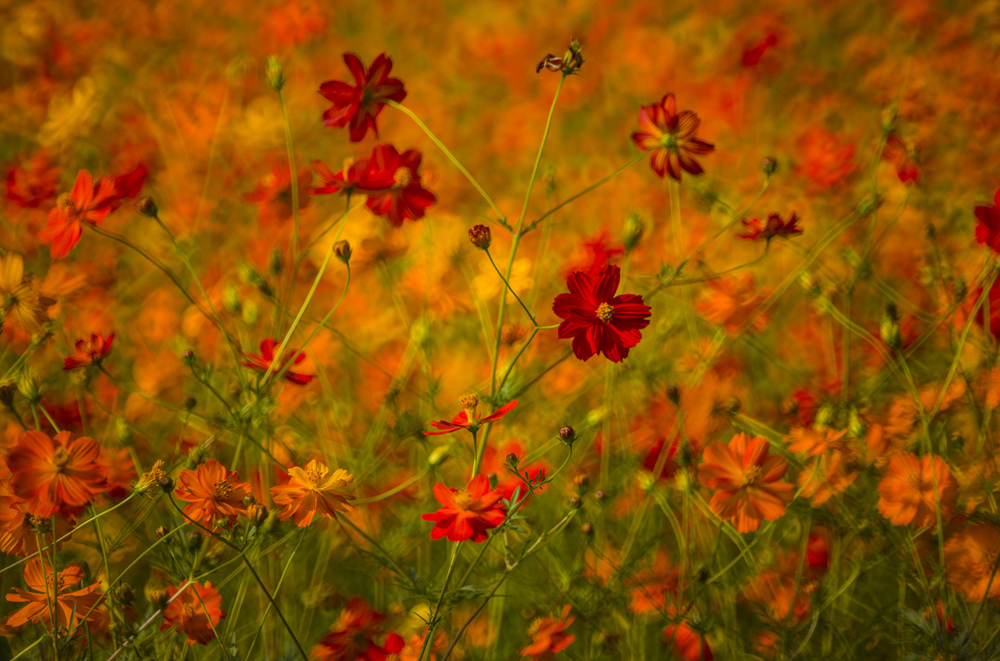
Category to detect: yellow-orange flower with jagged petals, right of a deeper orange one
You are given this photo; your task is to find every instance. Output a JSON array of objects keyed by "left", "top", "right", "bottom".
[{"left": 271, "top": 459, "right": 354, "bottom": 528}]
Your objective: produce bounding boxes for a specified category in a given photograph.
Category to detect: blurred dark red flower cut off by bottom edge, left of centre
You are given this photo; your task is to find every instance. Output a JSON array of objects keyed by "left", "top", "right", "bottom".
[{"left": 310, "top": 597, "right": 404, "bottom": 661}]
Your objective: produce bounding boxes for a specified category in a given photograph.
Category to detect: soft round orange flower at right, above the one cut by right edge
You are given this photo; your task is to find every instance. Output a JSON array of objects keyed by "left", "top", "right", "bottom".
[{"left": 878, "top": 452, "right": 958, "bottom": 528}]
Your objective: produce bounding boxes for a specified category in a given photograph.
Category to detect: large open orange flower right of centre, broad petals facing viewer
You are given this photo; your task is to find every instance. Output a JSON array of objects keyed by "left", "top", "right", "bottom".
[{"left": 698, "top": 433, "right": 793, "bottom": 533}]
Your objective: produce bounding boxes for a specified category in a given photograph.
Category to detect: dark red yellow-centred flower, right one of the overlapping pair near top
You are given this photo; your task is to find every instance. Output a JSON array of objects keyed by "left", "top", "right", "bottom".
[{"left": 358, "top": 145, "right": 437, "bottom": 227}]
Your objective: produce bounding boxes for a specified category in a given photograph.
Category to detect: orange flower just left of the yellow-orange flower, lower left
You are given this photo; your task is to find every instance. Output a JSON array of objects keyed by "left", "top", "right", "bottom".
[{"left": 174, "top": 459, "right": 250, "bottom": 528}]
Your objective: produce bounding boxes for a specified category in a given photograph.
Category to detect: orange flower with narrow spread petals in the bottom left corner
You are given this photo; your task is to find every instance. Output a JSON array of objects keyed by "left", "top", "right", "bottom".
[{"left": 7, "top": 558, "right": 104, "bottom": 629}]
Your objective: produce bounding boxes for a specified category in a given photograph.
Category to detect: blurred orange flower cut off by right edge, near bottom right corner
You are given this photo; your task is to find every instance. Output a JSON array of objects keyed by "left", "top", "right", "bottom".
[{"left": 944, "top": 523, "right": 1000, "bottom": 603}]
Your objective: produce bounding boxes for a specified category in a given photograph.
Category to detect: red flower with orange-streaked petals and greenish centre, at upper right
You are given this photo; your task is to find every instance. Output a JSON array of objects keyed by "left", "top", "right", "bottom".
[{"left": 632, "top": 93, "right": 715, "bottom": 181}]
